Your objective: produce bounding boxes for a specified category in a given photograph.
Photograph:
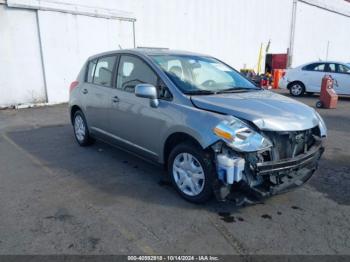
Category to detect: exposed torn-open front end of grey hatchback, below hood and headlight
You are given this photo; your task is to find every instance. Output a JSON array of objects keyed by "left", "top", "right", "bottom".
[{"left": 212, "top": 126, "right": 324, "bottom": 204}]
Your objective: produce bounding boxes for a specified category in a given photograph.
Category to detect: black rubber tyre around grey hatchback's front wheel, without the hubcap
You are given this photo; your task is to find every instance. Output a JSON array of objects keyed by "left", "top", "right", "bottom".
[{"left": 167, "top": 142, "right": 216, "bottom": 204}]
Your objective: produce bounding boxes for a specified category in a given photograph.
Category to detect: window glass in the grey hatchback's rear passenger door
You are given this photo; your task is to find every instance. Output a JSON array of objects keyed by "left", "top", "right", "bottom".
[{"left": 92, "top": 56, "right": 116, "bottom": 87}]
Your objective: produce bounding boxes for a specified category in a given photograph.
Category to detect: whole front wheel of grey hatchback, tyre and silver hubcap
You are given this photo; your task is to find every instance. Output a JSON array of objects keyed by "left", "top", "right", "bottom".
[{"left": 168, "top": 142, "right": 215, "bottom": 203}]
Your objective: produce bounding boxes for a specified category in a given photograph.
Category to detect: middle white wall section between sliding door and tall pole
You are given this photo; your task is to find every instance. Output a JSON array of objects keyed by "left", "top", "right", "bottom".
[{"left": 76, "top": 0, "right": 292, "bottom": 69}]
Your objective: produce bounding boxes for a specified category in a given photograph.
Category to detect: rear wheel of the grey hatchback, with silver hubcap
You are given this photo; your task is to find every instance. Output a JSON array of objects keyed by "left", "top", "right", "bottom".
[{"left": 73, "top": 110, "right": 94, "bottom": 146}]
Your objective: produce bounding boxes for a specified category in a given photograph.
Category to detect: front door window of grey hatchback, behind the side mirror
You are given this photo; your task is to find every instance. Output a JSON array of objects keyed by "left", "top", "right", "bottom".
[{"left": 117, "top": 55, "right": 158, "bottom": 93}]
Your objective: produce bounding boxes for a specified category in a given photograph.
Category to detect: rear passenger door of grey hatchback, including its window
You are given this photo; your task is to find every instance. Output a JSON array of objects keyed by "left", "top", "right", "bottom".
[{"left": 81, "top": 55, "right": 116, "bottom": 133}]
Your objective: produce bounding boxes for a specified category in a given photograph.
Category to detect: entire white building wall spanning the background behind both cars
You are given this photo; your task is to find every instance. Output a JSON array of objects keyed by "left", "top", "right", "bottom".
[{"left": 0, "top": 0, "right": 350, "bottom": 106}]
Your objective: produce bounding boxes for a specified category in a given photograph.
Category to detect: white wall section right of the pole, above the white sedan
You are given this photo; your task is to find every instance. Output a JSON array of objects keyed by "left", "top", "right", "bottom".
[{"left": 292, "top": 2, "right": 350, "bottom": 66}]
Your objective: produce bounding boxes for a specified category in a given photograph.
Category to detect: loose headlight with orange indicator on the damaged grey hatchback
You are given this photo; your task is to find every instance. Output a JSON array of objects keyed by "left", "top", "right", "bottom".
[{"left": 213, "top": 118, "right": 272, "bottom": 152}]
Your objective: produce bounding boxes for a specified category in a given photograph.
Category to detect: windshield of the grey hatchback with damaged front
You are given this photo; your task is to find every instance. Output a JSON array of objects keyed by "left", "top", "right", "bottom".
[{"left": 152, "top": 55, "right": 260, "bottom": 94}]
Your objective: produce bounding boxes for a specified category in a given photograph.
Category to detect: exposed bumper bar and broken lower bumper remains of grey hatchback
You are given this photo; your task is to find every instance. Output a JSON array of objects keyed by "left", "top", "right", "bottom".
[{"left": 214, "top": 139, "right": 324, "bottom": 204}]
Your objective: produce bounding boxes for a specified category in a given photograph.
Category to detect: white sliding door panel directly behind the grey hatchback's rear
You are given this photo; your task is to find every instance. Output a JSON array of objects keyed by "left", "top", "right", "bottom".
[{"left": 38, "top": 10, "right": 133, "bottom": 103}]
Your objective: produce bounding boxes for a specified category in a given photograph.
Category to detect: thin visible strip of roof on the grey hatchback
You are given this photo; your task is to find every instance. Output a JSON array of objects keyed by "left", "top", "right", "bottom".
[{"left": 89, "top": 47, "right": 208, "bottom": 59}]
